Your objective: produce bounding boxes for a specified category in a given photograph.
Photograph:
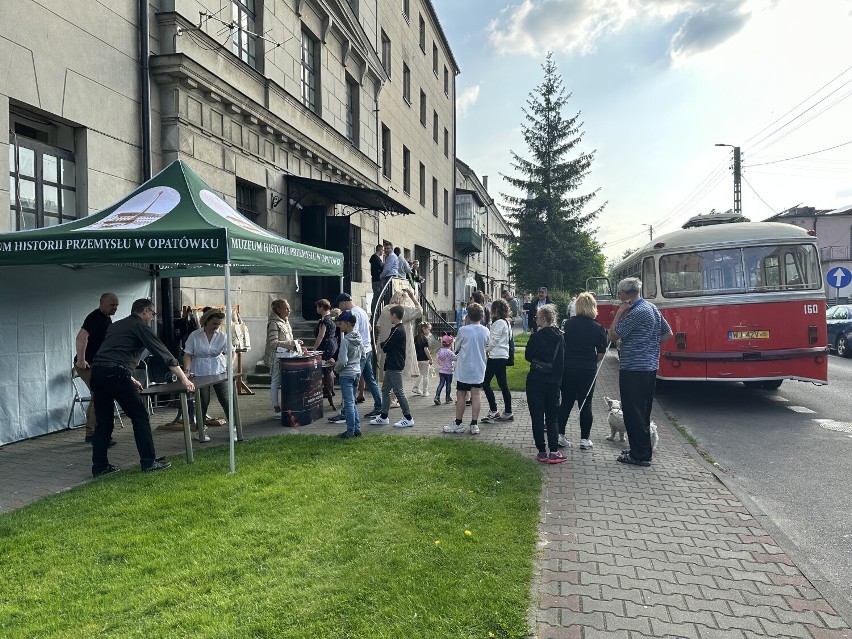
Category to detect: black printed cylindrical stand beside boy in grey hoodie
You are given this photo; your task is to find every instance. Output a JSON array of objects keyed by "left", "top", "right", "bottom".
[{"left": 278, "top": 353, "right": 322, "bottom": 427}]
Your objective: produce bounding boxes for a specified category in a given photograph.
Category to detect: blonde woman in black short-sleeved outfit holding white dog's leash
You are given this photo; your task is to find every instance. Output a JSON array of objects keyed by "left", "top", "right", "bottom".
[{"left": 559, "top": 293, "right": 607, "bottom": 450}]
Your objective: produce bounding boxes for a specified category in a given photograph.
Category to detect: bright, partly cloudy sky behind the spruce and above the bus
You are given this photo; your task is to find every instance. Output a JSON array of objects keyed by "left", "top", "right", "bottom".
[{"left": 433, "top": 0, "right": 852, "bottom": 260}]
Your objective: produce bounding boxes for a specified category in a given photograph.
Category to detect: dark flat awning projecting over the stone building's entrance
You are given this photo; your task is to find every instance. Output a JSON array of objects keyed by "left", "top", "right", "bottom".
[{"left": 286, "top": 175, "right": 414, "bottom": 215}]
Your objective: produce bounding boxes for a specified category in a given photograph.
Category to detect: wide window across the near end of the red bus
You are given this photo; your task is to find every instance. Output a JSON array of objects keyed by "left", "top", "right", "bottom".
[{"left": 660, "top": 244, "right": 822, "bottom": 297}]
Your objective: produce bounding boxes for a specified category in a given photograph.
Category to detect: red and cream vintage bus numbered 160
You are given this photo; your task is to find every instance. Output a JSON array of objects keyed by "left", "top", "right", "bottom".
[{"left": 590, "top": 222, "right": 828, "bottom": 389}]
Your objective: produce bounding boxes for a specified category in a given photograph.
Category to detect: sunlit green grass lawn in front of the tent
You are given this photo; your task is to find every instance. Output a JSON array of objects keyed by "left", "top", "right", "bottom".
[{"left": 0, "top": 438, "right": 541, "bottom": 639}]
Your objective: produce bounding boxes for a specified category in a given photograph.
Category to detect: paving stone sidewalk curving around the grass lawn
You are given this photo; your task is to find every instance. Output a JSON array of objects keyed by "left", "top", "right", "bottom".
[{"left": 0, "top": 355, "right": 852, "bottom": 639}]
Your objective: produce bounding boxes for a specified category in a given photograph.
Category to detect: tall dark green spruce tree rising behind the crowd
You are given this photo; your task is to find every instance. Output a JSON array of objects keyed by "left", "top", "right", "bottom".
[{"left": 503, "top": 52, "right": 605, "bottom": 293}]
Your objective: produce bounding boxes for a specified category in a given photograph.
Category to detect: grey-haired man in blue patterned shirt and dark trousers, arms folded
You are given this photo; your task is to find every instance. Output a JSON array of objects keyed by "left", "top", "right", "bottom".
[{"left": 609, "top": 277, "right": 674, "bottom": 466}]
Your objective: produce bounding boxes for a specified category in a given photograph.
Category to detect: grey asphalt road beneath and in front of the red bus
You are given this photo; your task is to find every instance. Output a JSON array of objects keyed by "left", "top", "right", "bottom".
[{"left": 657, "top": 355, "right": 852, "bottom": 611}]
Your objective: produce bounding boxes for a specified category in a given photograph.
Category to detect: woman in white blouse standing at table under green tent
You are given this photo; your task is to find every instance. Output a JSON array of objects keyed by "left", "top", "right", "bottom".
[{"left": 183, "top": 308, "right": 229, "bottom": 438}]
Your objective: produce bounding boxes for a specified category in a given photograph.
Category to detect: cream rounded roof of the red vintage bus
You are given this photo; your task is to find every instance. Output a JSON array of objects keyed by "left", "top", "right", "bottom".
[{"left": 644, "top": 222, "right": 816, "bottom": 252}]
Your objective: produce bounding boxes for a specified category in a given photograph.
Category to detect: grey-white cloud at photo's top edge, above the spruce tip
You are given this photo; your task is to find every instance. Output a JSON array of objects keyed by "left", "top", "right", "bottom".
[{"left": 487, "top": 0, "right": 756, "bottom": 57}]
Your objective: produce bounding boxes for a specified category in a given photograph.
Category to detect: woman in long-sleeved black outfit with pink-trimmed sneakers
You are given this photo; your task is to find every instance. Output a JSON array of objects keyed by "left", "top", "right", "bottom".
[{"left": 524, "top": 304, "right": 565, "bottom": 464}]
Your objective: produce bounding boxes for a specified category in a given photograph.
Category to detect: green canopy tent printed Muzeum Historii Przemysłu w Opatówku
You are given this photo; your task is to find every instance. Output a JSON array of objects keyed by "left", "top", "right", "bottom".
[{"left": 0, "top": 160, "right": 343, "bottom": 472}]
